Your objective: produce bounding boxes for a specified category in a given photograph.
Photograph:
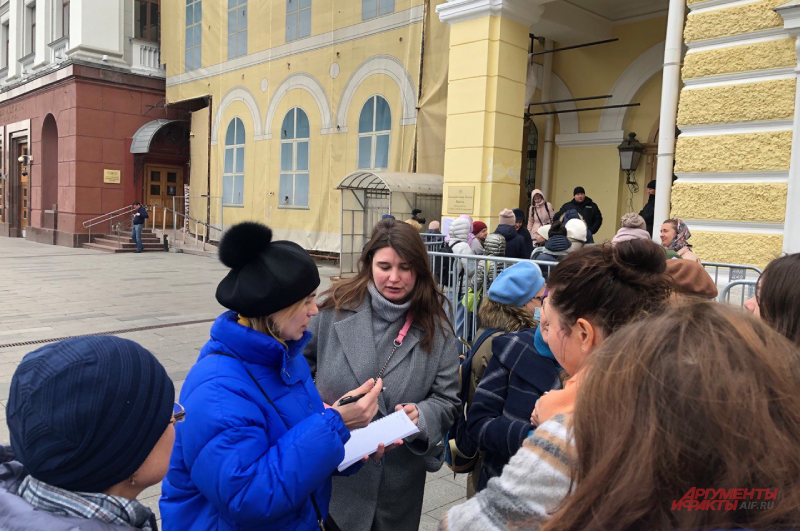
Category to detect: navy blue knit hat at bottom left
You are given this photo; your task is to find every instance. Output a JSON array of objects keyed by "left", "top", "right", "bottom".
[{"left": 6, "top": 336, "right": 175, "bottom": 492}]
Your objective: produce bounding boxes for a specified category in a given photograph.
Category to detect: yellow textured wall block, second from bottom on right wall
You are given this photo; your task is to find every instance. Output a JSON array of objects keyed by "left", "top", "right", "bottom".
[{"left": 672, "top": 182, "right": 787, "bottom": 223}]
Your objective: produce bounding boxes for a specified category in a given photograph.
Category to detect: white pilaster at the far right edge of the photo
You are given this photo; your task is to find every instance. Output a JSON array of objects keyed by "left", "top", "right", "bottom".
[{"left": 775, "top": 2, "right": 800, "bottom": 253}]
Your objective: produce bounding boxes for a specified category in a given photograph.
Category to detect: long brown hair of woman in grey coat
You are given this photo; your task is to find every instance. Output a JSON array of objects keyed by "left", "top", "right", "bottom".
[{"left": 319, "top": 219, "right": 453, "bottom": 352}]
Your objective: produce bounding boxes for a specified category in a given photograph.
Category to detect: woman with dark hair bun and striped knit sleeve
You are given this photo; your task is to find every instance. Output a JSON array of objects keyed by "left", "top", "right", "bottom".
[{"left": 441, "top": 240, "right": 671, "bottom": 531}]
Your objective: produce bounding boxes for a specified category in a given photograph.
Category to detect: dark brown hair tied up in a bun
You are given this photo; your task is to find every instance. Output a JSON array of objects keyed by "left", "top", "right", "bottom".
[{"left": 547, "top": 239, "right": 672, "bottom": 336}]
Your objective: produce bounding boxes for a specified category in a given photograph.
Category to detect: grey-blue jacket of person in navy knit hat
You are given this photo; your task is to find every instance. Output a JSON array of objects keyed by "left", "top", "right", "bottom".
[{"left": 0, "top": 446, "right": 135, "bottom": 531}]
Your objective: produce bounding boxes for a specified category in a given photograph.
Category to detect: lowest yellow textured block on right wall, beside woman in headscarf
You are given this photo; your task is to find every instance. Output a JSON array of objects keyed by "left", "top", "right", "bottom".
[{"left": 689, "top": 231, "right": 783, "bottom": 268}]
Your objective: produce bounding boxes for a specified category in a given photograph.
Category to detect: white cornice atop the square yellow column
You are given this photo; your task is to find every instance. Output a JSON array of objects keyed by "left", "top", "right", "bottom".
[{"left": 436, "top": 0, "right": 552, "bottom": 27}]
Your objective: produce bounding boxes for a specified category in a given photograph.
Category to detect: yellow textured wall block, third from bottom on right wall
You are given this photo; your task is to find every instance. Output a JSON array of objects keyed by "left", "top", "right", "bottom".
[{"left": 675, "top": 131, "right": 792, "bottom": 173}]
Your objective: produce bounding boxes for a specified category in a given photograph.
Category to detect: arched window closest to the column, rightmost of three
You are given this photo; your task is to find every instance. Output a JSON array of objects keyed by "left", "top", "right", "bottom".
[{"left": 278, "top": 107, "right": 310, "bottom": 208}]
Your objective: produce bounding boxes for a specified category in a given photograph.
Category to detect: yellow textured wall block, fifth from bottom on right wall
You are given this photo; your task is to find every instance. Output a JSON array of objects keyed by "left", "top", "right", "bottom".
[{"left": 682, "top": 39, "right": 797, "bottom": 79}]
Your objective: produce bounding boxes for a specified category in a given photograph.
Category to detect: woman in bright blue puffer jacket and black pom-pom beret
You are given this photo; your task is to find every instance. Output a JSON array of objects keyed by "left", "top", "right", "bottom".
[{"left": 160, "top": 223, "right": 382, "bottom": 531}]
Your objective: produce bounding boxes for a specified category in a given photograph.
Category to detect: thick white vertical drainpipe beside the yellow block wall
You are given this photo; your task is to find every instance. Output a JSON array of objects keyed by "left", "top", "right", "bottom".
[{"left": 653, "top": 0, "right": 686, "bottom": 243}]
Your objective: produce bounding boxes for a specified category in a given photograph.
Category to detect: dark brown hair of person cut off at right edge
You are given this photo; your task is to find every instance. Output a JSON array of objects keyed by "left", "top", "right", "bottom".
[{"left": 756, "top": 253, "right": 800, "bottom": 346}]
